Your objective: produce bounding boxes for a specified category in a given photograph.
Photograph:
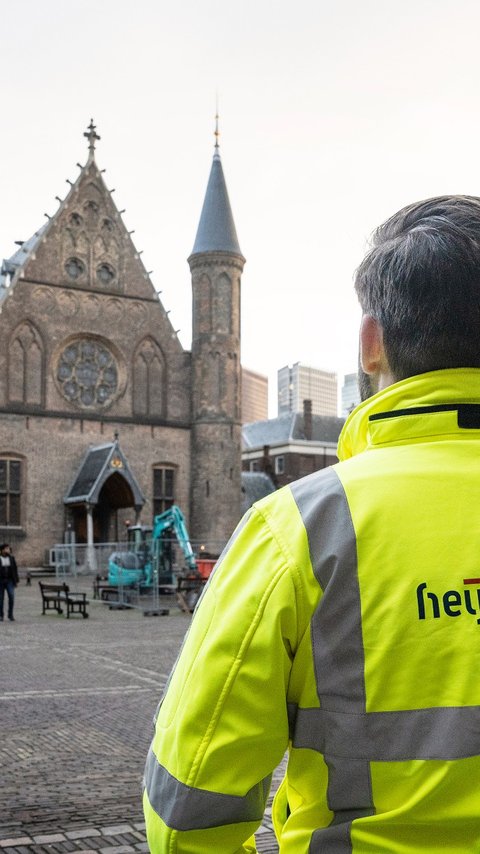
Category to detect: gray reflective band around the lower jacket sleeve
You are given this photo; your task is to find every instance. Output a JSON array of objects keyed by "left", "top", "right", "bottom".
[{"left": 144, "top": 749, "right": 272, "bottom": 830}]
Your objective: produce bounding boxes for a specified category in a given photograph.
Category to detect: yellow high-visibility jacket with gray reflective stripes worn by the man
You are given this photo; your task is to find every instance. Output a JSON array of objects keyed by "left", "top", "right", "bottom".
[{"left": 144, "top": 369, "right": 480, "bottom": 854}]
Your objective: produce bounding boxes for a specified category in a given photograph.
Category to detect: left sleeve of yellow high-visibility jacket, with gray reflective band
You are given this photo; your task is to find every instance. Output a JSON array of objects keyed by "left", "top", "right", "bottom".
[{"left": 144, "top": 493, "right": 308, "bottom": 854}]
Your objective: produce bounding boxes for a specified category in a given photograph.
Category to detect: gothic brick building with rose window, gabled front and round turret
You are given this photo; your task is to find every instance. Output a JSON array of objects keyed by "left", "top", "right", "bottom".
[{"left": 0, "top": 122, "right": 245, "bottom": 566}]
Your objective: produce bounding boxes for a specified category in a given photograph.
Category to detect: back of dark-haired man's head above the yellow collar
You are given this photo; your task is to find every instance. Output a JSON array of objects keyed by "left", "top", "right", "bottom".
[{"left": 355, "top": 196, "right": 480, "bottom": 380}]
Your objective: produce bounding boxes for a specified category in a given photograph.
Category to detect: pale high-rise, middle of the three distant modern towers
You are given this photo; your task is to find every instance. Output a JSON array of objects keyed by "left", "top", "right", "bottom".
[{"left": 278, "top": 362, "right": 338, "bottom": 415}]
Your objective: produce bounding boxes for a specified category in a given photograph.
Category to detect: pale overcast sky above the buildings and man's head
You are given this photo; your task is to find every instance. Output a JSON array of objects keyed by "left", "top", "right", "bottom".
[{"left": 0, "top": 0, "right": 480, "bottom": 416}]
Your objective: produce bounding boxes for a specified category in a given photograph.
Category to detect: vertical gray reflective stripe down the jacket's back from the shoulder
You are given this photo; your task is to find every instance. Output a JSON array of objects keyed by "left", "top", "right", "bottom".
[{"left": 291, "top": 468, "right": 375, "bottom": 854}]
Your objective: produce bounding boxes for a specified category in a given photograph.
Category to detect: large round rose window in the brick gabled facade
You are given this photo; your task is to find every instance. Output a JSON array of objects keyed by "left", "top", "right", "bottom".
[{"left": 57, "top": 340, "right": 118, "bottom": 408}]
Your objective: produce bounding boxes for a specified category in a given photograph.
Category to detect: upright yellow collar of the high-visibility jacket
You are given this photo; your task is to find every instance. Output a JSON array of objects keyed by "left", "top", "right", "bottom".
[{"left": 337, "top": 368, "right": 480, "bottom": 460}]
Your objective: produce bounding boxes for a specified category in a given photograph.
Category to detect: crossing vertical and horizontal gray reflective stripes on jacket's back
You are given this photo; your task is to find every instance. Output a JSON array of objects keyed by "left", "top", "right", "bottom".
[{"left": 288, "top": 469, "right": 480, "bottom": 854}]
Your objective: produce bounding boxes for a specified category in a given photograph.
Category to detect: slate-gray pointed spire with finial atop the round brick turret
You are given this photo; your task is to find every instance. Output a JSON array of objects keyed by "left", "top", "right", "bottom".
[{"left": 192, "top": 115, "right": 242, "bottom": 255}]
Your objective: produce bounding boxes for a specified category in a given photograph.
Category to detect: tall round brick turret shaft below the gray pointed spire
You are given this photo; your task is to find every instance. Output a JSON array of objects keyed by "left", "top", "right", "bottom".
[{"left": 189, "top": 252, "right": 243, "bottom": 552}]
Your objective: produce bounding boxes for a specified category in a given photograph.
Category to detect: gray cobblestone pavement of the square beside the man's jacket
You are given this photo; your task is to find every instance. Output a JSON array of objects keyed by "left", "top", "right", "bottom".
[{"left": 0, "top": 579, "right": 281, "bottom": 854}]
